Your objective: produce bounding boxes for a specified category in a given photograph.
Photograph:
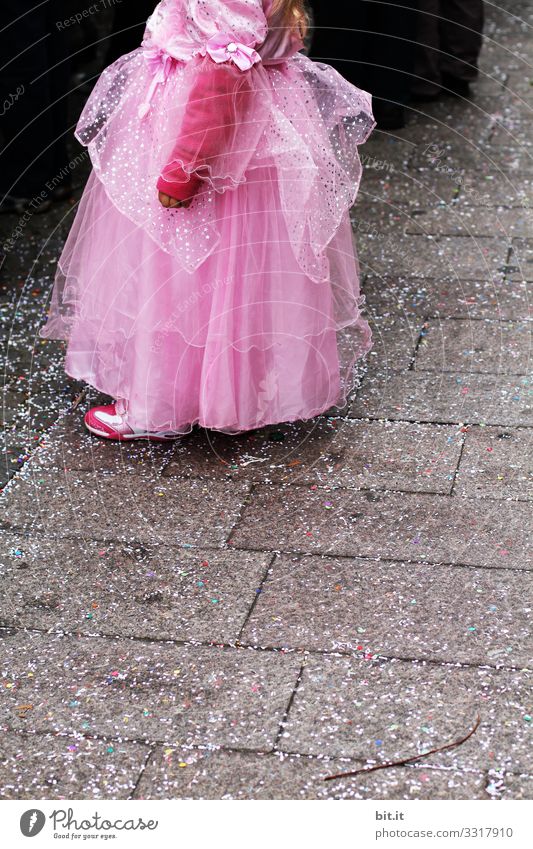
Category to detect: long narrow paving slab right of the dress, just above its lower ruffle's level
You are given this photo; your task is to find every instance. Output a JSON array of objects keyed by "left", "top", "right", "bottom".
[{"left": 363, "top": 275, "right": 533, "bottom": 321}]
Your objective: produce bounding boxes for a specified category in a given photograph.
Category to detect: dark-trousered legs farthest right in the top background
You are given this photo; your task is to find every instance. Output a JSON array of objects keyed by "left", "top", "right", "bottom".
[{"left": 412, "top": 0, "right": 483, "bottom": 100}]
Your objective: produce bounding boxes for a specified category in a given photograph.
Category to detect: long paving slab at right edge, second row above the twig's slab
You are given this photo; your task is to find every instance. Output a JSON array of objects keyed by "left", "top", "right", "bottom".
[{"left": 230, "top": 486, "right": 531, "bottom": 569}]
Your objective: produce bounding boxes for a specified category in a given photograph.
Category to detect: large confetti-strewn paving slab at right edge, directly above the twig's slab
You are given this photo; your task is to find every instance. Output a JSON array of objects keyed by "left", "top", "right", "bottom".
[{"left": 242, "top": 555, "right": 533, "bottom": 667}]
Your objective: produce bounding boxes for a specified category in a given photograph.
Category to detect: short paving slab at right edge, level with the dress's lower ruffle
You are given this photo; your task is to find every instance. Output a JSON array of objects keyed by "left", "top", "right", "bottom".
[{"left": 415, "top": 319, "right": 533, "bottom": 375}]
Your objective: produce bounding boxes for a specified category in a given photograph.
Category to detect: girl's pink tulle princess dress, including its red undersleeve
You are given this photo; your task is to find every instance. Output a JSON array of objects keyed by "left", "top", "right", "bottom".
[{"left": 41, "top": 0, "right": 374, "bottom": 434}]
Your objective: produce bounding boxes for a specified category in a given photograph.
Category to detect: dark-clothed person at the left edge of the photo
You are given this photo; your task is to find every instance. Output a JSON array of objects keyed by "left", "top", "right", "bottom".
[{"left": 0, "top": 0, "right": 70, "bottom": 213}]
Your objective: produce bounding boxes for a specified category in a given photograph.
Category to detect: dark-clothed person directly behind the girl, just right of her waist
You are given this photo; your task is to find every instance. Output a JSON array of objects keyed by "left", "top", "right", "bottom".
[{"left": 310, "top": 0, "right": 418, "bottom": 129}]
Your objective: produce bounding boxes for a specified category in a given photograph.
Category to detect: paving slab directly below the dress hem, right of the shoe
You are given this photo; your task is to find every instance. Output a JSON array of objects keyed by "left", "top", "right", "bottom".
[{"left": 163, "top": 418, "right": 463, "bottom": 493}]
